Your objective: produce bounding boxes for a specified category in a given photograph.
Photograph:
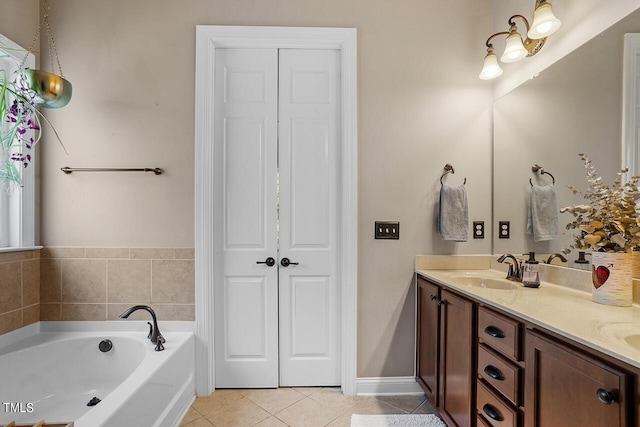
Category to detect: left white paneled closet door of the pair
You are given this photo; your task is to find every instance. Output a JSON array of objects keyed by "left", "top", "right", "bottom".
[{"left": 214, "top": 49, "right": 278, "bottom": 388}]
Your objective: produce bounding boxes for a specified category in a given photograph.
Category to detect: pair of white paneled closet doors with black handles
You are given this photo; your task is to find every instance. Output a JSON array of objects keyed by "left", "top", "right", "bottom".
[{"left": 214, "top": 49, "right": 341, "bottom": 388}]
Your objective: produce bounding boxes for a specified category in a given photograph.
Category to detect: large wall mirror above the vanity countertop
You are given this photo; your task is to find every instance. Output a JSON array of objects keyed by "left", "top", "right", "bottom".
[{"left": 493, "top": 10, "right": 640, "bottom": 267}]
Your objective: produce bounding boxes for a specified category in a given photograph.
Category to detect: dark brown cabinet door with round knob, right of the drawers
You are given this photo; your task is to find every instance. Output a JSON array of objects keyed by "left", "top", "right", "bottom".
[{"left": 525, "top": 331, "right": 631, "bottom": 427}]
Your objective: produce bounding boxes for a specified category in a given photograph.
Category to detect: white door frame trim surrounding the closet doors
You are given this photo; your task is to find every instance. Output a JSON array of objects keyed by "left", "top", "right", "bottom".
[{"left": 194, "top": 25, "right": 358, "bottom": 396}]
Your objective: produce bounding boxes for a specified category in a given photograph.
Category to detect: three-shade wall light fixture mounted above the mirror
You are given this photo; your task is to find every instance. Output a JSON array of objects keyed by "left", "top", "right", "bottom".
[{"left": 480, "top": 0, "right": 560, "bottom": 80}]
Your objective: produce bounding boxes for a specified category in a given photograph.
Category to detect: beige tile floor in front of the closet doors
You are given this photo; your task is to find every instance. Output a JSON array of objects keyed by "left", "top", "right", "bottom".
[{"left": 180, "top": 388, "right": 436, "bottom": 427}]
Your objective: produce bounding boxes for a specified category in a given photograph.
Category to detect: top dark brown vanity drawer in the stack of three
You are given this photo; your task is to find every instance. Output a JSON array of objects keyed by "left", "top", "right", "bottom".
[{"left": 478, "top": 307, "right": 522, "bottom": 361}]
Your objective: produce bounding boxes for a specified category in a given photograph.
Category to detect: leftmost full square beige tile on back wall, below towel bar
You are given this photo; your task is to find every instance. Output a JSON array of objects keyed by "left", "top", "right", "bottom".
[{"left": 62, "top": 259, "right": 107, "bottom": 303}]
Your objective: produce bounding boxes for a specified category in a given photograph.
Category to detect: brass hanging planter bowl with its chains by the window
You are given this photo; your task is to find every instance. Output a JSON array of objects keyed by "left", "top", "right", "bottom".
[{"left": 22, "top": 0, "right": 72, "bottom": 108}]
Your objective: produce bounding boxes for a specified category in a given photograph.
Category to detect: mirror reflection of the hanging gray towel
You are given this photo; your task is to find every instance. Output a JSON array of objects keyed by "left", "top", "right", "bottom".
[{"left": 527, "top": 185, "right": 558, "bottom": 242}]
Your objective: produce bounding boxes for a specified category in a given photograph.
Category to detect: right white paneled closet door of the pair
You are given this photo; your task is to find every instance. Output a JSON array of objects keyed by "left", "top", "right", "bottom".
[{"left": 279, "top": 49, "right": 340, "bottom": 386}]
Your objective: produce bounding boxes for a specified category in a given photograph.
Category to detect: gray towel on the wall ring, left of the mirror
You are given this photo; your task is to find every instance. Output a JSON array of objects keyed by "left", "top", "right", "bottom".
[{"left": 438, "top": 185, "right": 469, "bottom": 242}]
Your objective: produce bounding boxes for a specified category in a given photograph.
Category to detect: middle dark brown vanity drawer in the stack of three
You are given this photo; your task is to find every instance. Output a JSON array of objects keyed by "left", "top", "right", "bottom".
[{"left": 478, "top": 344, "right": 522, "bottom": 406}]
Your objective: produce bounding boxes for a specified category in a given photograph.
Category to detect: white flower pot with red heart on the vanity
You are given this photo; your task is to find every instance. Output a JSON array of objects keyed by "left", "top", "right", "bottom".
[{"left": 591, "top": 252, "right": 633, "bottom": 307}]
